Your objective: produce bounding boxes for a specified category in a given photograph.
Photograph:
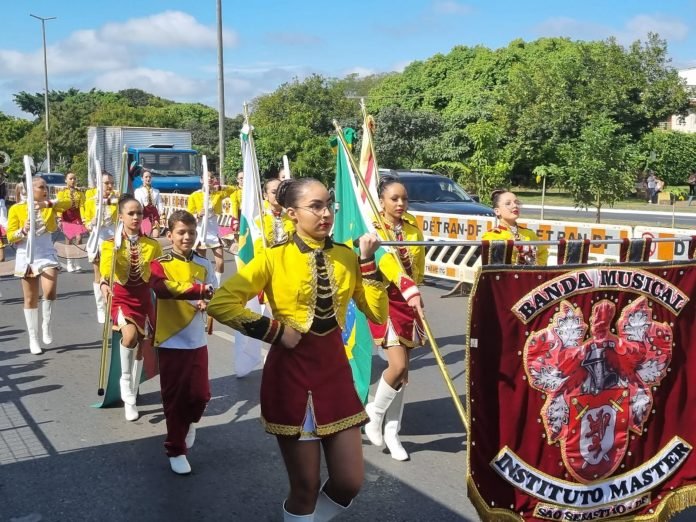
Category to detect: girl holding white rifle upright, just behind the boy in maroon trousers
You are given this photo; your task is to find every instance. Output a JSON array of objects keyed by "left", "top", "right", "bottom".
[{"left": 186, "top": 172, "right": 237, "bottom": 287}]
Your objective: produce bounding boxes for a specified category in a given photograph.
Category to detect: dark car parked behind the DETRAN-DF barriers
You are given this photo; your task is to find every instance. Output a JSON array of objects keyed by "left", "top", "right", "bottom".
[{"left": 379, "top": 169, "right": 495, "bottom": 217}]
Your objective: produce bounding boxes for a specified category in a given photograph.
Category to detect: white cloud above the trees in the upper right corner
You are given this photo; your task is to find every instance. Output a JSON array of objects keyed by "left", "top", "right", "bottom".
[{"left": 536, "top": 14, "right": 689, "bottom": 45}]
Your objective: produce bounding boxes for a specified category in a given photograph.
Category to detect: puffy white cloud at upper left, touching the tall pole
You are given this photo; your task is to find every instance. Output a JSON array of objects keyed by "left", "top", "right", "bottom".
[{"left": 100, "top": 11, "right": 239, "bottom": 49}]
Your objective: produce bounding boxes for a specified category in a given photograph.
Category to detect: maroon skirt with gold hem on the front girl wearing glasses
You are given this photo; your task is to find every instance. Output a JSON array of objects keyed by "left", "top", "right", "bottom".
[{"left": 261, "top": 327, "right": 368, "bottom": 437}]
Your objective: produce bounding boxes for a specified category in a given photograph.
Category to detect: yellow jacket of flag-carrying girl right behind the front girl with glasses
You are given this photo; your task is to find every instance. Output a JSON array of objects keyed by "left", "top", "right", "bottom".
[{"left": 374, "top": 213, "right": 425, "bottom": 301}]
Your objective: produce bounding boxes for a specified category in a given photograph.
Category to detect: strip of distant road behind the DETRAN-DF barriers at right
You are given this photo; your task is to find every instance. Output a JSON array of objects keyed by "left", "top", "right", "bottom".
[{"left": 523, "top": 205, "right": 696, "bottom": 228}]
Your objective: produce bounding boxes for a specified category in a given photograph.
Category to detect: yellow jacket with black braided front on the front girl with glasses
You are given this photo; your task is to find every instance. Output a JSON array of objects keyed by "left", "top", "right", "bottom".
[{"left": 208, "top": 234, "right": 388, "bottom": 343}]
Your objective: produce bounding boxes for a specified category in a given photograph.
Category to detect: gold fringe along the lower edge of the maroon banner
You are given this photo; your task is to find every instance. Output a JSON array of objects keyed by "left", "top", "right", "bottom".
[{"left": 466, "top": 475, "right": 696, "bottom": 522}]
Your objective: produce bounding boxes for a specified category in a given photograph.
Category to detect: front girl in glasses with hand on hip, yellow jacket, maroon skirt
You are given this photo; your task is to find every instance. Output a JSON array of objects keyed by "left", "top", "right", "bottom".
[{"left": 208, "top": 178, "right": 387, "bottom": 521}]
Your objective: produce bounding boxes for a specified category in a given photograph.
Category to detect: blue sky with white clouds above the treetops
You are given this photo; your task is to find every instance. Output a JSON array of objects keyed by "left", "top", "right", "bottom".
[{"left": 0, "top": 0, "right": 696, "bottom": 116}]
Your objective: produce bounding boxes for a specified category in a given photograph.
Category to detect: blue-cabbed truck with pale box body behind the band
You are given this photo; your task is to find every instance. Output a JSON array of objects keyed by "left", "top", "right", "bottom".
[{"left": 87, "top": 127, "right": 201, "bottom": 194}]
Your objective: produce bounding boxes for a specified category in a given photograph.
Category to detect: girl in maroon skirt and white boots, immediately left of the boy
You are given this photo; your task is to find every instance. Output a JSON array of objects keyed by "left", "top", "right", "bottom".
[{"left": 99, "top": 194, "right": 162, "bottom": 421}]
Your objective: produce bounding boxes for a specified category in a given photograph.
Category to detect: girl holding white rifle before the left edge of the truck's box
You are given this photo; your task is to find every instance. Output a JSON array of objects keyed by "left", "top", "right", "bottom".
[{"left": 82, "top": 171, "right": 118, "bottom": 324}]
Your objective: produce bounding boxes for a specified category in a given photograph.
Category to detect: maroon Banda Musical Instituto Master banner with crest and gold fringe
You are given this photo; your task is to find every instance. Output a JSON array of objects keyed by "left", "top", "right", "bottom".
[{"left": 467, "top": 262, "right": 696, "bottom": 521}]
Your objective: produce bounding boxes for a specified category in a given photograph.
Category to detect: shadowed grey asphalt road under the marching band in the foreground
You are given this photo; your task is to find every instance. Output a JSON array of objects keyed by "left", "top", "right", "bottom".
[{"left": 0, "top": 263, "right": 477, "bottom": 522}]
